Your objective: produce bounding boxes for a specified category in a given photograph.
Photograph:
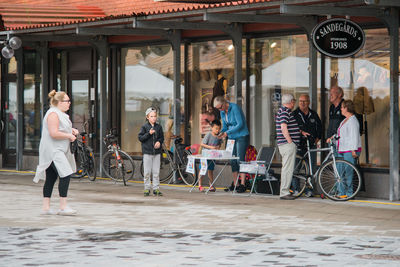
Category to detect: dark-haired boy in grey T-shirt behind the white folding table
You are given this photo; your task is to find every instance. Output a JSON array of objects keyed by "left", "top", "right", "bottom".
[{"left": 199, "top": 120, "right": 222, "bottom": 192}]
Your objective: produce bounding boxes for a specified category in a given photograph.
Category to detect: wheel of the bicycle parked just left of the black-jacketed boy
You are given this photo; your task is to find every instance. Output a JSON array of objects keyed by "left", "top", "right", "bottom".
[{"left": 102, "top": 151, "right": 135, "bottom": 183}]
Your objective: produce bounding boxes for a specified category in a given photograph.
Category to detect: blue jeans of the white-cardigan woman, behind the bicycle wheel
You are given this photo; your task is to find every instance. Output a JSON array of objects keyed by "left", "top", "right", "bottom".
[{"left": 336, "top": 152, "right": 360, "bottom": 196}]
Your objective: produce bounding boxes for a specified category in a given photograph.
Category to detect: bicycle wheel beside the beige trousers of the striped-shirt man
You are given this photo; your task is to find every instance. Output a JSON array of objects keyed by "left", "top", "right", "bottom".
[{"left": 290, "top": 155, "right": 310, "bottom": 197}]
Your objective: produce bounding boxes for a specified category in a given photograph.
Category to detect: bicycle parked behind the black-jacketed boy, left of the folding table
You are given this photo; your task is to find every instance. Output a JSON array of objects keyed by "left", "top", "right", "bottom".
[{"left": 140, "top": 136, "right": 196, "bottom": 185}]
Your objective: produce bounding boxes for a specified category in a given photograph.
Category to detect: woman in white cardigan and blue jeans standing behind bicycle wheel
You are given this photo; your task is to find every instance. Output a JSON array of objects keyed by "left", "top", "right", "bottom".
[{"left": 337, "top": 100, "right": 361, "bottom": 197}]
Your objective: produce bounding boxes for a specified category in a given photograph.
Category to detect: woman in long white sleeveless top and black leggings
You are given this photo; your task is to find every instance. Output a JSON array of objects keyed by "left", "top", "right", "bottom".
[{"left": 33, "top": 90, "right": 78, "bottom": 215}]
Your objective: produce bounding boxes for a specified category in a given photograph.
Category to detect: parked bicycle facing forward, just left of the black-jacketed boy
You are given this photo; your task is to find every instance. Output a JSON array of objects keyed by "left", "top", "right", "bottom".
[{"left": 101, "top": 129, "right": 135, "bottom": 186}]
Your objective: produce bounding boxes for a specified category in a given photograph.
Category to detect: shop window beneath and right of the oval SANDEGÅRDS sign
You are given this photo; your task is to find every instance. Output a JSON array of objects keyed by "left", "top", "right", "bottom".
[{"left": 325, "top": 29, "right": 390, "bottom": 167}]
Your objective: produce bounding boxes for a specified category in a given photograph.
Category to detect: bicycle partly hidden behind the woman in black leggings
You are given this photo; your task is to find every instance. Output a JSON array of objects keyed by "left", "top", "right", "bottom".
[{"left": 71, "top": 123, "right": 96, "bottom": 181}]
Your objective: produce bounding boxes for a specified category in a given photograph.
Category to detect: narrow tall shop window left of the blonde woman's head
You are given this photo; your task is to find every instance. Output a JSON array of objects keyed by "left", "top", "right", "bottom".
[{"left": 24, "top": 52, "right": 42, "bottom": 151}]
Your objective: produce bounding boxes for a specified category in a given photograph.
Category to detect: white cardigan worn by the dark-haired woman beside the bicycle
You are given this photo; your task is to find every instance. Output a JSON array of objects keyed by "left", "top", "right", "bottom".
[{"left": 337, "top": 115, "right": 361, "bottom": 152}]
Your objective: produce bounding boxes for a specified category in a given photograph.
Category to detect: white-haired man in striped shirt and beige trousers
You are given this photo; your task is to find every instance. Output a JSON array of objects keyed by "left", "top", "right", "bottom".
[{"left": 275, "top": 94, "right": 300, "bottom": 200}]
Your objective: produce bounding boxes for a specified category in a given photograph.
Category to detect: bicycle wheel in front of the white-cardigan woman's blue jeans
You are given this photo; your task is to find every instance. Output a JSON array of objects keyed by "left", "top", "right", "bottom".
[{"left": 318, "top": 159, "right": 361, "bottom": 201}]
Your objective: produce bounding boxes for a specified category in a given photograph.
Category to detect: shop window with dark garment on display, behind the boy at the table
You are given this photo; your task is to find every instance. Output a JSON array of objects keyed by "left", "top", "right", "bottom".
[{"left": 189, "top": 40, "right": 238, "bottom": 144}]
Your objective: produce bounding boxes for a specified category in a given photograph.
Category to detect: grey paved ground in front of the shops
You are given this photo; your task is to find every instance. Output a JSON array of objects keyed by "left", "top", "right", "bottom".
[{"left": 0, "top": 171, "right": 400, "bottom": 266}]
